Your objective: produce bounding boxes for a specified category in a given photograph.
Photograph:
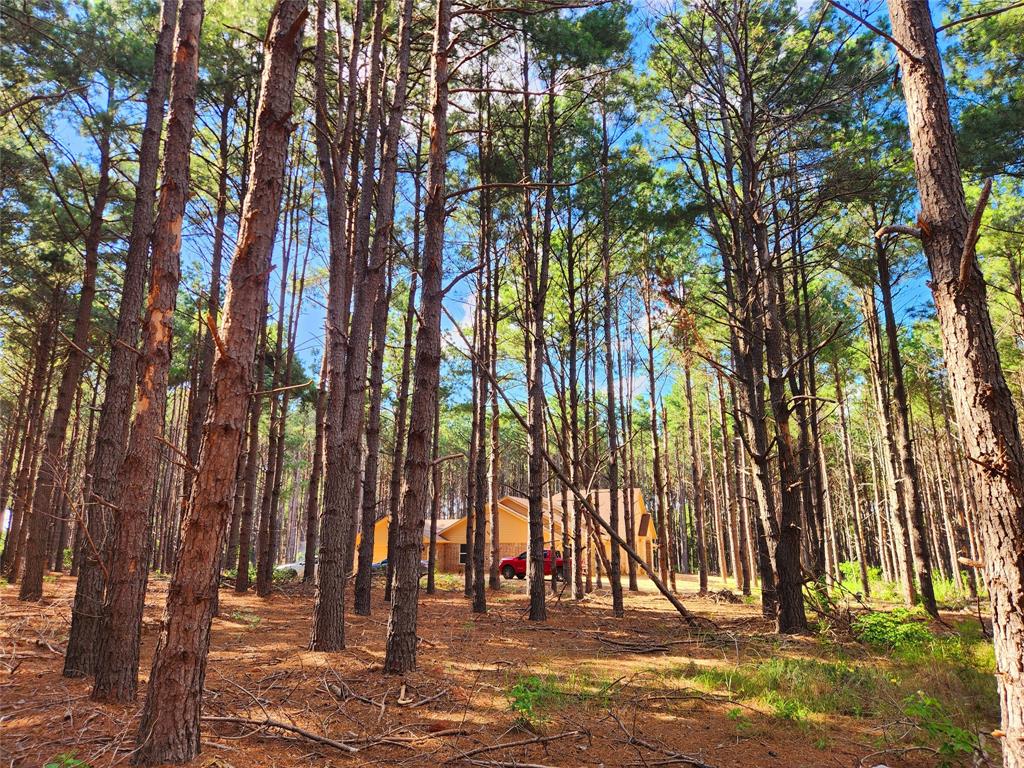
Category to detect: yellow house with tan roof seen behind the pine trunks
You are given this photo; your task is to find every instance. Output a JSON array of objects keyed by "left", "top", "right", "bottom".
[{"left": 434, "top": 488, "right": 657, "bottom": 572}]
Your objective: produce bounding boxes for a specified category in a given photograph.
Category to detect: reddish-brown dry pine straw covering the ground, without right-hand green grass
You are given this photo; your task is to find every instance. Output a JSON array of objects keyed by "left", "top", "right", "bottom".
[{"left": 0, "top": 575, "right": 946, "bottom": 768}]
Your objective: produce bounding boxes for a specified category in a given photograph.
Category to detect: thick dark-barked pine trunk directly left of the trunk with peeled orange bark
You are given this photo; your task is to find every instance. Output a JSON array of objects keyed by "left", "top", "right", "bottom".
[{"left": 63, "top": 0, "right": 178, "bottom": 677}]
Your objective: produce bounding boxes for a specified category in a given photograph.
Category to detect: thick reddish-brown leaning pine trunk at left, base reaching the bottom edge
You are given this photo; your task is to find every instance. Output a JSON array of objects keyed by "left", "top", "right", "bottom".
[{"left": 134, "top": 0, "right": 307, "bottom": 765}]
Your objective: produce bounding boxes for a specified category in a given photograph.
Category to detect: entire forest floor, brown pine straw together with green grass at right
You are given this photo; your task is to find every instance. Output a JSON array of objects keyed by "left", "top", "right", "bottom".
[{"left": 0, "top": 574, "right": 998, "bottom": 768}]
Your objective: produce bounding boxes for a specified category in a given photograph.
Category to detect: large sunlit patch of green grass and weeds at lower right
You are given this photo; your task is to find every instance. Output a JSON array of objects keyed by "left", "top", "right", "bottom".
[{"left": 673, "top": 622, "right": 999, "bottom": 766}]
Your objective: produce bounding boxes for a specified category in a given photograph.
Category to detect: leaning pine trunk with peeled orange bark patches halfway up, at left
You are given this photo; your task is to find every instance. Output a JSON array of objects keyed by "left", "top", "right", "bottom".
[{"left": 92, "top": 0, "right": 205, "bottom": 702}]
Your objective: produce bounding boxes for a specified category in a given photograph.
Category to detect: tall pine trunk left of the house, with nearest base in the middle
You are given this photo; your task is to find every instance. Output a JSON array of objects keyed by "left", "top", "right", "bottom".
[{"left": 384, "top": 0, "right": 452, "bottom": 674}]
